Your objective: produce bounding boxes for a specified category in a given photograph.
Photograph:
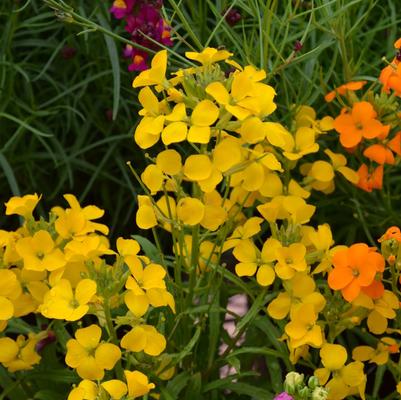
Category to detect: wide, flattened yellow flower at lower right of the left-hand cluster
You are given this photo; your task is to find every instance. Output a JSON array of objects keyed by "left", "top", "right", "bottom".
[{"left": 121, "top": 325, "right": 166, "bottom": 356}]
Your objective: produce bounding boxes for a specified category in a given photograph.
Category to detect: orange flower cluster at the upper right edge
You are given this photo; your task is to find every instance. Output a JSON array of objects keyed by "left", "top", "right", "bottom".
[{"left": 325, "top": 40, "right": 401, "bottom": 192}]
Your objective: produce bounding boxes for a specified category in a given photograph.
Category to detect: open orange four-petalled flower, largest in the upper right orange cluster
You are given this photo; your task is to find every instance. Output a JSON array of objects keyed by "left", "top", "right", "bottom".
[{"left": 334, "top": 101, "right": 388, "bottom": 148}]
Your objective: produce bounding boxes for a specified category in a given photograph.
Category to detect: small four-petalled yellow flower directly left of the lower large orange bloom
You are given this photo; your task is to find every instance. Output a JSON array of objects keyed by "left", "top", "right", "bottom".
[{"left": 274, "top": 243, "right": 307, "bottom": 279}]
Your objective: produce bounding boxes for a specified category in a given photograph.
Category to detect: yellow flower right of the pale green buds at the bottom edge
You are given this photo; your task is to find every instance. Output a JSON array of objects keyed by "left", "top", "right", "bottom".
[{"left": 315, "top": 343, "right": 366, "bottom": 400}]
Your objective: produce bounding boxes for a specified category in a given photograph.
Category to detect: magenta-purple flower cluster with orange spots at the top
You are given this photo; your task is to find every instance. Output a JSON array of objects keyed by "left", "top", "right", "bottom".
[{"left": 110, "top": 0, "right": 173, "bottom": 71}]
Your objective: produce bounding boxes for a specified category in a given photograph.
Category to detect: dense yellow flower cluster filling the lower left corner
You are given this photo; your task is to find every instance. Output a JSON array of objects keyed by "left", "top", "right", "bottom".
[{"left": 0, "top": 194, "right": 175, "bottom": 400}]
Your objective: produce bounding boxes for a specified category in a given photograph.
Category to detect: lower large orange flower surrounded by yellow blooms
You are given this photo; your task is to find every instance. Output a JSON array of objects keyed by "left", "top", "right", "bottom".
[{"left": 328, "top": 243, "right": 385, "bottom": 302}]
